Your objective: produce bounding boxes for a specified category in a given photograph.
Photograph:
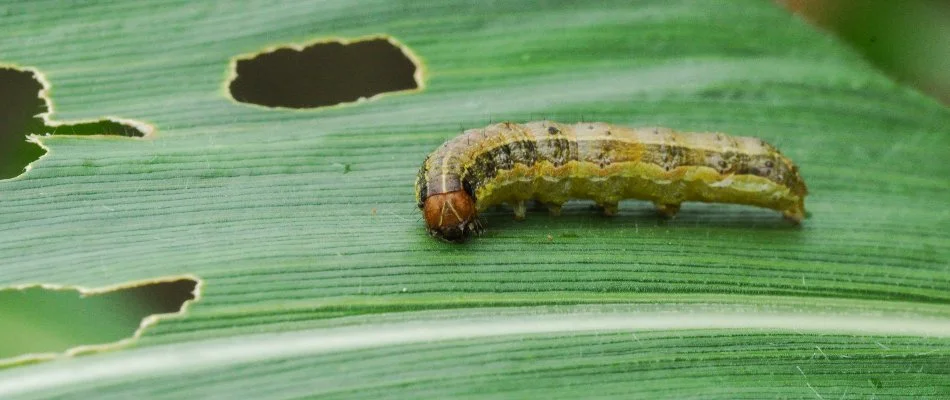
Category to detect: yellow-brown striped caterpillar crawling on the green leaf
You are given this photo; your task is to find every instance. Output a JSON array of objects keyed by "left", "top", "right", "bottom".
[{"left": 416, "top": 121, "right": 808, "bottom": 242}]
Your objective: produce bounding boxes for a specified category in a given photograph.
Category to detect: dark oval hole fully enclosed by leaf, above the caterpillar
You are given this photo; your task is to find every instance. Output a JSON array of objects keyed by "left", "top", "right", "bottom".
[{"left": 229, "top": 38, "right": 420, "bottom": 108}]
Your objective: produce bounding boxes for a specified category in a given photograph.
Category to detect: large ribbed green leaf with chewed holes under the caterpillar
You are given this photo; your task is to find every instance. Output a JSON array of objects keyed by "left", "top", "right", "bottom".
[{"left": 0, "top": 0, "right": 950, "bottom": 398}]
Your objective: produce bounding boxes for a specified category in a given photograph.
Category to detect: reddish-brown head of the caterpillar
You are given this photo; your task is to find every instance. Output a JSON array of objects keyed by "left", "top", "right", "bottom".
[{"left": 422, "top": 190, "right": 481, "bottom": 242}]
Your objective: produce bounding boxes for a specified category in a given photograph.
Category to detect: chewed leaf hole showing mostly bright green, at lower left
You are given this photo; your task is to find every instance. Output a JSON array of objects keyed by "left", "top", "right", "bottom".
[{"left": 0, "top": 279, "right": 198, "bottom": 360}]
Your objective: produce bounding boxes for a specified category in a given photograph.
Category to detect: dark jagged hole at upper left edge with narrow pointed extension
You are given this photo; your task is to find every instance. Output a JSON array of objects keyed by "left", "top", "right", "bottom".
[{"left": 0, "top": 68, "right": 145, "bottom": 179}]
